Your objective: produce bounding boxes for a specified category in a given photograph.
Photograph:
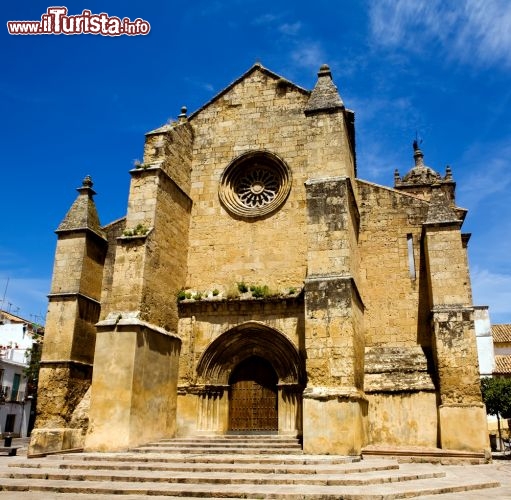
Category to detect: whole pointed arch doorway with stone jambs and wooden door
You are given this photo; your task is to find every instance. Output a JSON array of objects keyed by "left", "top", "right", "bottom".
[{"left": 197, "top": 321, "right": 305, "bottom": 436}]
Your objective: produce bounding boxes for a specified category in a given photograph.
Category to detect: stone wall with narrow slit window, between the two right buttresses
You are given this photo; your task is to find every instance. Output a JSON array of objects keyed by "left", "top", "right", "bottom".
[{"left": 355, "top": 180, "right": 430, "bottom": 346}]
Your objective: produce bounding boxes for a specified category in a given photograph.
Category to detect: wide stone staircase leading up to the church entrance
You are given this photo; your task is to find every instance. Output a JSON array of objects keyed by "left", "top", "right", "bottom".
[{"left": 0, "top": 435, "right": 499, "bottom": 500}]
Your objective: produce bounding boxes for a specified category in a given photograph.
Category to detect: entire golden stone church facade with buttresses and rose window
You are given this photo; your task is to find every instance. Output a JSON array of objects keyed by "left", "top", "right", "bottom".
[{"left": 29, "top": 64, "right": 488, "bottom": 455}]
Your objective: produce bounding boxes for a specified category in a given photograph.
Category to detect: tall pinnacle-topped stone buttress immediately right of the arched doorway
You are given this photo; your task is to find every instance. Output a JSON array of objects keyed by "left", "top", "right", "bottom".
[{"left": 303, "top": 65, "right": 367, "bottom": 455}]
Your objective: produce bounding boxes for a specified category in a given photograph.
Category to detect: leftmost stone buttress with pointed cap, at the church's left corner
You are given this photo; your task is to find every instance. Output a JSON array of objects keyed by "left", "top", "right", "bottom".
[{"left": 29, "top": 177, "right": 107, "bottom": 455}]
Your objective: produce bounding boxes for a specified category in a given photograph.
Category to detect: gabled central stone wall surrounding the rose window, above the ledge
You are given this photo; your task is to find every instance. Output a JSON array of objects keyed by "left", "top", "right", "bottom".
[{"left": 186, "top": 70, "right": 311, "bottom": 291}]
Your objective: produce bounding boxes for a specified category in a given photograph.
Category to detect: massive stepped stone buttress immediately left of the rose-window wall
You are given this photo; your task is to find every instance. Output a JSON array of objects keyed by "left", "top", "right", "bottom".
[{"left": 86, "top": 119, "right": 193, "bottom": 450}]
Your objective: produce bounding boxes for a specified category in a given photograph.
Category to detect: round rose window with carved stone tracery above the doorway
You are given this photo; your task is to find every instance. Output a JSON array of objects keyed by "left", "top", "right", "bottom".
[{"left": 219, "top": 152, "right": 291, "bottom": 217}]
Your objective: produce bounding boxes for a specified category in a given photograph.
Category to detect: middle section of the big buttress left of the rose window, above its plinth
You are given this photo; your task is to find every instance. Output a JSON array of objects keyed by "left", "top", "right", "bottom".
[{"left": 107, "top": 167, "right": 191, "bottom": 331}]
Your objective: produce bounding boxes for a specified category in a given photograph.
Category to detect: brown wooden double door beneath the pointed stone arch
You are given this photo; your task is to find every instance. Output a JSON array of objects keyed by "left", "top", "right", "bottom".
[{"left": 229, "top": 356, "right": 279, "bottom": 431}]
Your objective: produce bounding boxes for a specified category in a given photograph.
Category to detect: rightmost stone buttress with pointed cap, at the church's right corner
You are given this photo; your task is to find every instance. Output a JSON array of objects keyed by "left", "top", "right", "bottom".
[{"left": 423, "top": 183, "right": 489, "bottom": 451}]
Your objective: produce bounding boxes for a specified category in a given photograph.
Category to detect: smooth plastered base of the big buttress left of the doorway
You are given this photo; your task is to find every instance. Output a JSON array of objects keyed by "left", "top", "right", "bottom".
[{"left": 85, "top": 326, "right": 180, "bottom": 451}]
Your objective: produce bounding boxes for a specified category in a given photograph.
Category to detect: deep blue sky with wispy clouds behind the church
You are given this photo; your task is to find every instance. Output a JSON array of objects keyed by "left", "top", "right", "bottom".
[{"left": 0, "top": 0, "right": 511, "bottom": 323}]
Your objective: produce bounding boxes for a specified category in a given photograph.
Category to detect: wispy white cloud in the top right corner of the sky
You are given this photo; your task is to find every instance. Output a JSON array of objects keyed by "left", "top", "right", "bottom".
[{"left": 370, "top": 0, "right": 511, "bottom": 67}]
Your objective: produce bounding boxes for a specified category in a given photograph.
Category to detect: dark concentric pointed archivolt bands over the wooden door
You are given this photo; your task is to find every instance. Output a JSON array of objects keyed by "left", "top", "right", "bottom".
[{"left": 197, "top": 321, "right": 305, "bottom": 387}]
